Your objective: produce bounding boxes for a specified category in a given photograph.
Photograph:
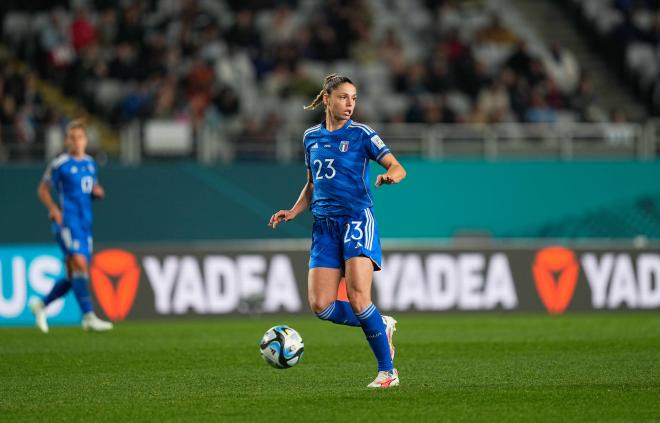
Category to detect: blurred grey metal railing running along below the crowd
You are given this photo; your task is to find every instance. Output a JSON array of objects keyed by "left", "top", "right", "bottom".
[{"left": 0, "top": 120, "right": 660, "bottom": 165}]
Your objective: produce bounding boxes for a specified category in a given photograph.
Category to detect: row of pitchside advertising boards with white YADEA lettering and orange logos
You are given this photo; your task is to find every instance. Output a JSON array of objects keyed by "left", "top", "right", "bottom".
[{"left": 0, "top": 240, "right": 660, "bottom": 325}]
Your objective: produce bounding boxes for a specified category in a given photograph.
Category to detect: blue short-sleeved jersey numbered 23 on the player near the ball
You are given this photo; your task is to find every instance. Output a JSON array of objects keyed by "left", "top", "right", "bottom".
[{"left": 303, "top": 119, "right": 390, "bottom": 217}]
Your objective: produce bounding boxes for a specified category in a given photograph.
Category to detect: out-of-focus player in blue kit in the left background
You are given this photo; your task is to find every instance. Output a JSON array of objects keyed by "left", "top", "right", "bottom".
[{"left": 30, "top": 120, "right": 112, "bottom": 333}]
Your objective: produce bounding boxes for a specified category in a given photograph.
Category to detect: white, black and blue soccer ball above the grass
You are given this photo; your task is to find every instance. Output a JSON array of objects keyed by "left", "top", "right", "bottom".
[{"left": 259, "top": 325, "right": 305, "bottom": 369}]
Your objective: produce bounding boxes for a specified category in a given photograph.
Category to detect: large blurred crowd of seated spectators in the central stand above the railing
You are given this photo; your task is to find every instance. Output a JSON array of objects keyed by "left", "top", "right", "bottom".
[{"left": 3, "top": 0, "right": 625, "bottom": 142}]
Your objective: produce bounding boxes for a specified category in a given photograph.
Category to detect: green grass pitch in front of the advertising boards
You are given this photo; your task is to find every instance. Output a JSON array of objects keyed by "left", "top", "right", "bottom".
[{"left": 0, "top": 312, "right": 660, "bottom": 423}]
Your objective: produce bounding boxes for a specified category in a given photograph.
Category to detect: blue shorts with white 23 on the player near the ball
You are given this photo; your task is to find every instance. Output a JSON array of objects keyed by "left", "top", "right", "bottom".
[{"left": 309, "top": 209, "right": 383, "bottom": 271}]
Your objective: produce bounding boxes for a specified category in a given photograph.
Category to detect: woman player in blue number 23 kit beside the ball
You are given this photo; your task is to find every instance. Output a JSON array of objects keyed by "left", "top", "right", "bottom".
[{"left": 269, "top": 74, "right": 406, "bottom": 388}]
